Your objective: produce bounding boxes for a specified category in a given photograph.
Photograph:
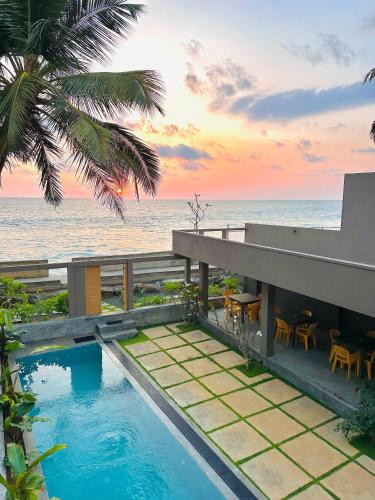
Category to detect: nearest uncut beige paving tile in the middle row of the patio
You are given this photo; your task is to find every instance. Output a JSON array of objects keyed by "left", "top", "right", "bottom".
[{"left": 280, "top": 432, "right": 347, "bottom": 477}]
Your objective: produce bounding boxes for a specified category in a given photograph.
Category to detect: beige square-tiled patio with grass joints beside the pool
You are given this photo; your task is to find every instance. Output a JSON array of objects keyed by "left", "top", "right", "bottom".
[{"left": 122, "top": 324, "right": 375, "bottom": 499}]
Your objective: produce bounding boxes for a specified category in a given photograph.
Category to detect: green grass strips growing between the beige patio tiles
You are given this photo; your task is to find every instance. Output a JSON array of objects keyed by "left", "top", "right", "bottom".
[{"left": 119, "top": 324, "right": 375, "bottom": 498}]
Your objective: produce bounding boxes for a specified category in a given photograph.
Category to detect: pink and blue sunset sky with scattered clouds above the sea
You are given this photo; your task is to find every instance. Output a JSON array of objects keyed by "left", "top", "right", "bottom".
[{"left": 0, "top": 0, "right": 375, "bottom": 199}]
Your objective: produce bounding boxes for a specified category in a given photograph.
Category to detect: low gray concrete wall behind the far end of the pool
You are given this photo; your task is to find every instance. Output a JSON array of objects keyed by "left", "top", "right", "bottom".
[{"left": 21, "top": 304, "right": 182, "bottom": 343}]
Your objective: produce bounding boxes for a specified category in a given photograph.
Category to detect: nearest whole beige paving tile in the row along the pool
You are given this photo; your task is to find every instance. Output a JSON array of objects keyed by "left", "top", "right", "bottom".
[{"left": 241, "top": 449, "right": 311, "bottom": 499}]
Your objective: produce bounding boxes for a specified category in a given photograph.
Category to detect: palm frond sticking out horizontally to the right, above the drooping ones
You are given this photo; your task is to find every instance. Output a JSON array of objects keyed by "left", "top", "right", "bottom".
[{"left": 55, "top": 71, "right": 164, "bottom": 117}]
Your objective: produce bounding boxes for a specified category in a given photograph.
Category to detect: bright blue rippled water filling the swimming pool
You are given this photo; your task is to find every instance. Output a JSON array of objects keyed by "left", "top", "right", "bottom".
[{"left": 18, "top": 344, "right": 224, "bottom": 500}]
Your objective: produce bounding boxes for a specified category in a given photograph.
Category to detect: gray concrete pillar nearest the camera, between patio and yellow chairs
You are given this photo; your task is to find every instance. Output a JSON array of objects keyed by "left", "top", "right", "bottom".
[{"left": 260, "top": 283, "right": 276, "bottom": 358}]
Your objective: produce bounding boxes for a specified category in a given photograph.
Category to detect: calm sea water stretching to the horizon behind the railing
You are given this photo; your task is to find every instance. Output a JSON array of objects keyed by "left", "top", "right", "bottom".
[{"left": 0, "top": 198, "right": 342, "bottom": 261}]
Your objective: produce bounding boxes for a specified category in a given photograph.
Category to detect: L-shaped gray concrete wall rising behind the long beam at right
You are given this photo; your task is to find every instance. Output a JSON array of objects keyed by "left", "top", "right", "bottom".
[{"left": 245, "top": 172, "right": 375, "bottom": 264}]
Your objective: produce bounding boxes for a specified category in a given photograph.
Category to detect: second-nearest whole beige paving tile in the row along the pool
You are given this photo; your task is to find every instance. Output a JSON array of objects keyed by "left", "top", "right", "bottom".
[{"left": 210, "top": 422, "right": 270, "bottom": 462}]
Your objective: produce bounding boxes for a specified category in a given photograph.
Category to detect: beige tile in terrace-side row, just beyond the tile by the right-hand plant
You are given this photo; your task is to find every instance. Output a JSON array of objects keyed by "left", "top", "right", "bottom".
[{"left": 282, "top": 396, "right": 336, "bottom": 427}]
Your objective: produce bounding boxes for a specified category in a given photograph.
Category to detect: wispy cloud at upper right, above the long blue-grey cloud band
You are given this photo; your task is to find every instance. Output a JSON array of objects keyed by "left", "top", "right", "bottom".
[{"left": 284, "top": 33, "right": 356, "bottom": 66}]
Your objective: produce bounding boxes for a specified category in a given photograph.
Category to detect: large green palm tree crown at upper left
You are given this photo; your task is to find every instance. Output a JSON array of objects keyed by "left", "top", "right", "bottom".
[{"left": 0, "top": 0, "right": 164, "bottom": 217}]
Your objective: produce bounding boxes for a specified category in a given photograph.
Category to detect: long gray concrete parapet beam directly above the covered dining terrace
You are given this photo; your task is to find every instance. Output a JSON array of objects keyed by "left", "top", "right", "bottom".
[{"left": 173, "top": 231, "right": 375, "bottom": 316}]
